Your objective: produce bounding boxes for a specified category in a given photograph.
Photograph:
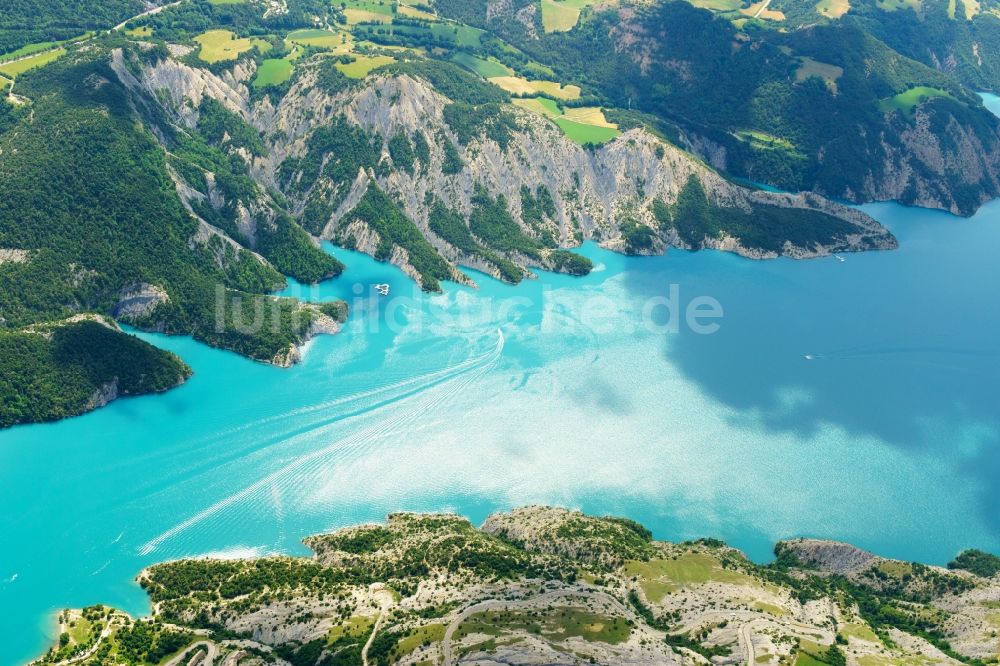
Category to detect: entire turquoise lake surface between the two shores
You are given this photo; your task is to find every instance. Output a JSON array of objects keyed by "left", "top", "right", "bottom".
[{"left": 0, "top": 99, "right": 1000, "bottom": 664}]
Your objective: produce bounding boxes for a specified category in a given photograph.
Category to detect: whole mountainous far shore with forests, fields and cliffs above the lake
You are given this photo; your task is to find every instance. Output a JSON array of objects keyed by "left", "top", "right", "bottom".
[{"left": 0, "top": 0, "right": 1000, "bottom": 422}]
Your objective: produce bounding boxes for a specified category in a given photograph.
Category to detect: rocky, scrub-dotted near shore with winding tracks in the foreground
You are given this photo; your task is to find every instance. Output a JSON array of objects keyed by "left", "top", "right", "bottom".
[{"left": 29, "top": 507, "right": 1000, "bottom": 666}]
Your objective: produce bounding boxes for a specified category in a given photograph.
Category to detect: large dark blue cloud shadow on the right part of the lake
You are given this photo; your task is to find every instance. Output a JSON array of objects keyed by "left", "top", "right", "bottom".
[{"left": 628, "top": 201, "right": 1000, "bottom": 536}]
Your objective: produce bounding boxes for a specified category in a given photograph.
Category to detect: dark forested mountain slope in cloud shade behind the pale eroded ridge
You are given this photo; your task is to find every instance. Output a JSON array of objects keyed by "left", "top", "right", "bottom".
[{"left": 437, "top": 0, "right": 1000, "bottom": 215}]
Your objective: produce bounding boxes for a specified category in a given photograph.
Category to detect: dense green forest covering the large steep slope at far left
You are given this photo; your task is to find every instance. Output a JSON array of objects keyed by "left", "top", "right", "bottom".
[{"left": 0, "top": 51, "right": 338, "bottom": 424}]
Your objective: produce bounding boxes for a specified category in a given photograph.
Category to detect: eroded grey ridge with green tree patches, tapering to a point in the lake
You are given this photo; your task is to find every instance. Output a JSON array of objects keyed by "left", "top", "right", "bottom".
[{"left": 136, "top": 48, "right": 894, "bottom": 289}]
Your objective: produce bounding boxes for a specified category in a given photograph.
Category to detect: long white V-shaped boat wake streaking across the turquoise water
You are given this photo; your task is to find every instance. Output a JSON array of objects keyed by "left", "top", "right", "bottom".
[{"left": 138, "top": 329, "right": 504, "bottom": 556}]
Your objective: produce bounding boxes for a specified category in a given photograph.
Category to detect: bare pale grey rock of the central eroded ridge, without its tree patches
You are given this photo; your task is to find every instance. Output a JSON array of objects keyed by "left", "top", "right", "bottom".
[{"left": 127, "top": 54, "right": 896, "bottom": 288}]
